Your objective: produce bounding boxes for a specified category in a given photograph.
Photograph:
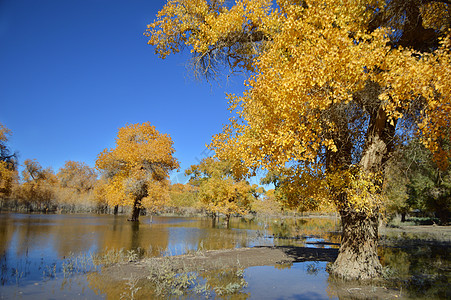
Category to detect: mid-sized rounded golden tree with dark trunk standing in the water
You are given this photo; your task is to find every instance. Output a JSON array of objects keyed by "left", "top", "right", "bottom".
[{"left": 96, "top": 122, "right": 179, "bottom": 221}]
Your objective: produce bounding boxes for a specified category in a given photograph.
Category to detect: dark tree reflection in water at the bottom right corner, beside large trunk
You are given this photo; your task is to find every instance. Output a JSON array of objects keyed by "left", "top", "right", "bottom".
[{"left": 328, "top": 244, "right": 451, "bottom": 299}]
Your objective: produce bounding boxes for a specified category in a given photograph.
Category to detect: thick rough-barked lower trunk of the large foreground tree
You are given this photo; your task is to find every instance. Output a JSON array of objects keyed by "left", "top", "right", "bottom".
[{"left": 328, "top": 209, "right": 382, "bottom": 280}]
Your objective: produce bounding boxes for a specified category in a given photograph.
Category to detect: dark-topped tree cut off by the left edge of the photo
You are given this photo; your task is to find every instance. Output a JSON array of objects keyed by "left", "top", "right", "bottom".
[{"left": 0, "top": 123, "right": 17, "bottom": 199}]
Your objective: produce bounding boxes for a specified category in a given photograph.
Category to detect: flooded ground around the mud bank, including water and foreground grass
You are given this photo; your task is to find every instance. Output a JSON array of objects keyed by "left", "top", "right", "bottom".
[{"left": 0, "top": 213, "right": 451, "bottom": 299}]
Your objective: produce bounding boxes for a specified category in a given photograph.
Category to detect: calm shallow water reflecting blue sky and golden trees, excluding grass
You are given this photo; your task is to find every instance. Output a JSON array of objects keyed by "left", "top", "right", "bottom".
[{"left": 0, "top": 213, "right": 450, "bottom": 299}]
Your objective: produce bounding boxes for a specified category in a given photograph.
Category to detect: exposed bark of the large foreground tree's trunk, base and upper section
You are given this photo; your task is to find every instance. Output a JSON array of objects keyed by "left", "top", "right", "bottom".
[{"left": 328, "top": 99, "right": 396, "bottom": 280}]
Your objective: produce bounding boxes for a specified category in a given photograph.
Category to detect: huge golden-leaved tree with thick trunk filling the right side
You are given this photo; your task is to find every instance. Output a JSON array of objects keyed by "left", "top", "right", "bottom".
[{"left": 145, "top": 0, "right": 451, "bottom": 279}]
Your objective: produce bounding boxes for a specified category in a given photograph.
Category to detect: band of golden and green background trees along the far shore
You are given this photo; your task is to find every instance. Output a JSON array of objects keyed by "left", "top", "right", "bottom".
[{"left": 0, "top": 119, "right": 451, "bottom": 225}]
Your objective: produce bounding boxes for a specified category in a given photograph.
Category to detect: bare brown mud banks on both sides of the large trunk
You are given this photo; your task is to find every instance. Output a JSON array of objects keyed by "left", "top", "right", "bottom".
[{"left": 102, "top": 226, "right": 451, "bottom": 281}]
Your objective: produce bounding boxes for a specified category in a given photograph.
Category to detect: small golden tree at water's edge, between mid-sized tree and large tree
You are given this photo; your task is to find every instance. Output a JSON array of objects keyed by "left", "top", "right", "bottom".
[{"left": 185, "top": 157, "right": 255, "bottom": 225}]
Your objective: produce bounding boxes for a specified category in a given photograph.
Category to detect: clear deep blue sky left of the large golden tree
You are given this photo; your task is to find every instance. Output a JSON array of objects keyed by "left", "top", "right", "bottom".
[{"left": 0, "top": 0, "right": 252, "bottom": 181}]
